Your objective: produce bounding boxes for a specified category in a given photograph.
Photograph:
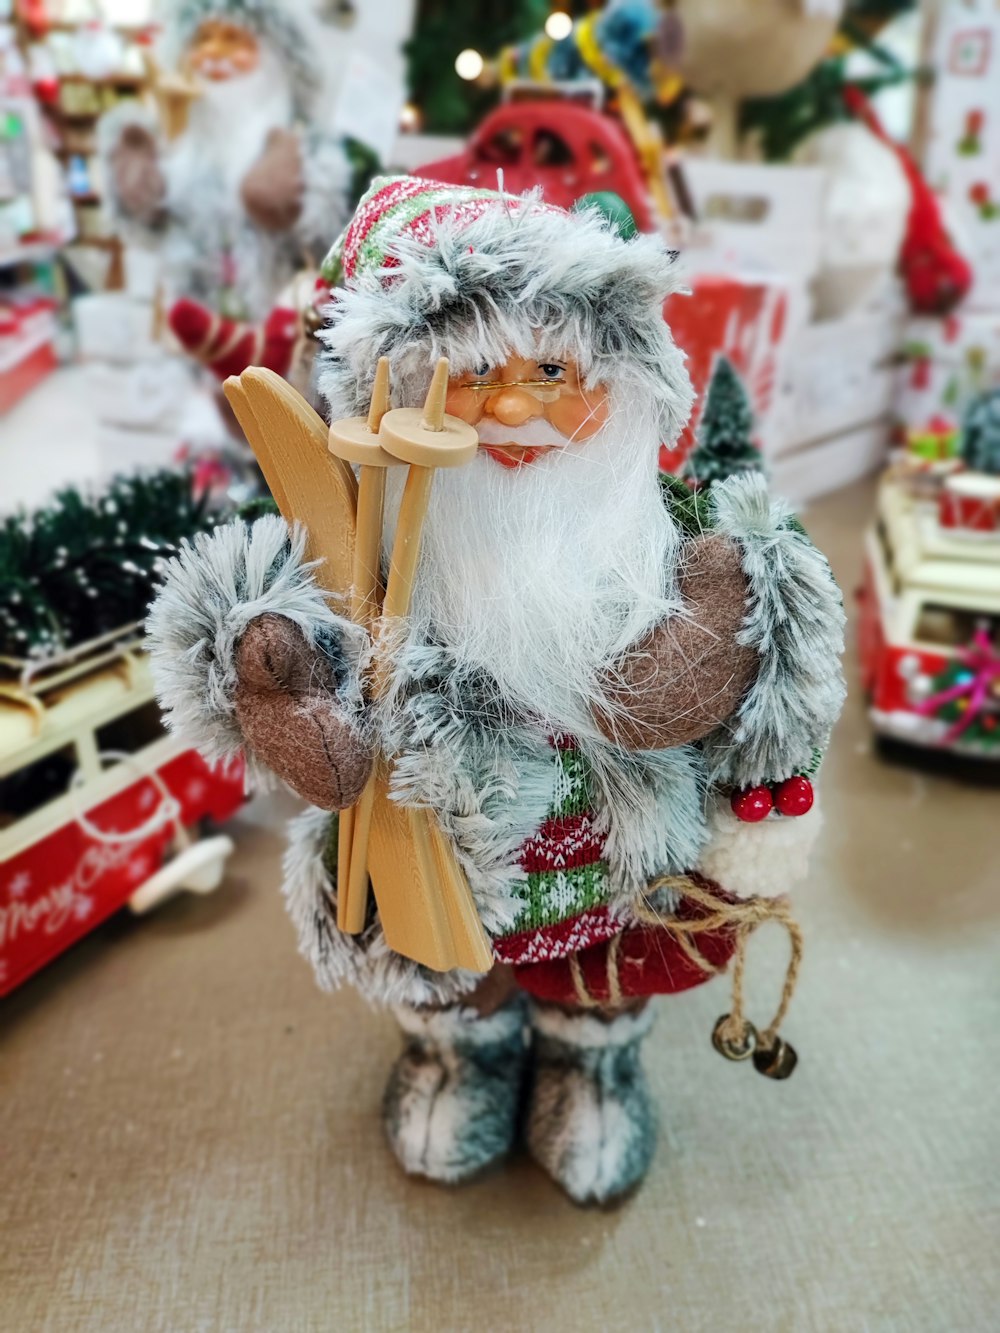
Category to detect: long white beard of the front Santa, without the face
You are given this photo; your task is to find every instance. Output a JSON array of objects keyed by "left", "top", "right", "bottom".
[{"left": 385, "top": 389, "right": 680, "bottom": 740}]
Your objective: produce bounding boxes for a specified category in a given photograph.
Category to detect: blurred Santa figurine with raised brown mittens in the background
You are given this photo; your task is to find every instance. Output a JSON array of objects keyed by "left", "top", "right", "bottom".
[{"left": 100, "top": 0, "right": 353, "bottom": 377}]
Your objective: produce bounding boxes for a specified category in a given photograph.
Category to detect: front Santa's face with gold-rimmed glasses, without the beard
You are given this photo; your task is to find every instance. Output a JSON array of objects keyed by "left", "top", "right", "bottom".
[{"left": 447, "top": 353, "right": 609, "bottom": 469}]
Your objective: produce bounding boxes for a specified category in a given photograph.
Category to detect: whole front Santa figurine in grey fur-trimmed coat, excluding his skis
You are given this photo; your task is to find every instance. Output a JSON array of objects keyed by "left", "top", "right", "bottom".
[{"left": 148, "top": 179, "right": 844, "bottom": 1202}]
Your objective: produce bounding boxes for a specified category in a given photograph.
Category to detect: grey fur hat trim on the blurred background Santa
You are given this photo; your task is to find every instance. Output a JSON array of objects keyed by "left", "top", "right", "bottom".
[{"left": 163, "top": 0, "right": 321, "bottom": 119}]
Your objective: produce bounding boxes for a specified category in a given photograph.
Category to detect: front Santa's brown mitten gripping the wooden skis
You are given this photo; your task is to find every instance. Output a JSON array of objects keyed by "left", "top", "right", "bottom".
[{"left": 236, "top": 615, "right": 372, "bottom": 810}]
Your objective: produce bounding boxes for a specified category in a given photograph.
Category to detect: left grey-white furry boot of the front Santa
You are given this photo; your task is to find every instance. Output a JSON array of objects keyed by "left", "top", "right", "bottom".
[{"left": 383, "top": 996, "right": 528, "bottom": 1184}]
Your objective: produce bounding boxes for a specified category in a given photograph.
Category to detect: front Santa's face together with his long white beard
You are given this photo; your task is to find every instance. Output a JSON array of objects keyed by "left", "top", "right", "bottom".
[{"left": 383, "top": 351, "right": 679, "bottom": 738}]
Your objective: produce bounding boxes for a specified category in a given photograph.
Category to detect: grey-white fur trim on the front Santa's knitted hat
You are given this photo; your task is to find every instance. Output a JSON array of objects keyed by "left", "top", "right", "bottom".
[{"left": 317, "top": 195, "right": 692, "bottom": 441}]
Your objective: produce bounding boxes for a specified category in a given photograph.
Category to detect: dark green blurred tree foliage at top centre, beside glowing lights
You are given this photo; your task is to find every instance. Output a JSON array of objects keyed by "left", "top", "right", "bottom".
[{"left": 405, "top": 0, "right": 551, "bottom": 135}]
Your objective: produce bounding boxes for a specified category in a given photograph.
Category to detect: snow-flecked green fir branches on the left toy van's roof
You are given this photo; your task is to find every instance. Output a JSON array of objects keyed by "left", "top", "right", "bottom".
[{"left": 0, "top": 472, "right": 223, "bottom": 659}]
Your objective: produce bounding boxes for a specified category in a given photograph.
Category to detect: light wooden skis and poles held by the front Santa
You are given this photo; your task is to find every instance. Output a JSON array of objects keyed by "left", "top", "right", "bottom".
[{"left": 225, "top": 357, "right": 493, "bottom": 972}]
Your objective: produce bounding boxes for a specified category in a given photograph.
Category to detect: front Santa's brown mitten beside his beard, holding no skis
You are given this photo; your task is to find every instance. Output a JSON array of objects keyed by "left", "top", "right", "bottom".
[{"left": 597, "top": 536, "right": 760, "bottom": 749}]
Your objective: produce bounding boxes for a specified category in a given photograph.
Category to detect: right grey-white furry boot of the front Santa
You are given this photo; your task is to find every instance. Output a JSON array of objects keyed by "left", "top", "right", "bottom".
[{"left": 527, "top": 1004, "right": 656, "bottom": 1204}]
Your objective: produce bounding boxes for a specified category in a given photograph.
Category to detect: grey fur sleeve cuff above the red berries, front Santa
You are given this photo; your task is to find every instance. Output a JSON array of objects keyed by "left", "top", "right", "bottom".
[{"left": 704, "top": 475, "right": 845, "bottom": 786}]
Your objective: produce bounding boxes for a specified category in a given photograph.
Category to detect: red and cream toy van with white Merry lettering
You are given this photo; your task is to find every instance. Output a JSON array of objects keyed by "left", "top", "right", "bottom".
[{"left": 0, "top": 627, "right": 244, "bottom": 996}]
